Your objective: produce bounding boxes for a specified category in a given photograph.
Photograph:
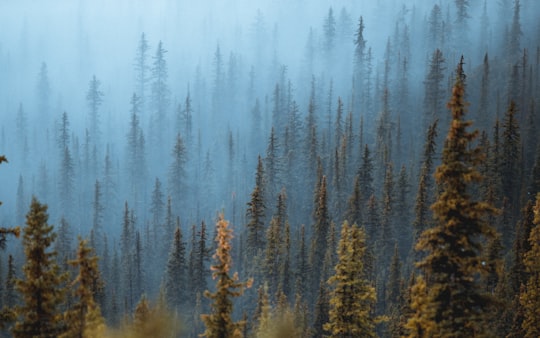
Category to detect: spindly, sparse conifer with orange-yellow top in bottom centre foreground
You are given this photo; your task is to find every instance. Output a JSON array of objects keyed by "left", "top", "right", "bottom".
[{"left": 201, "top": 214, "right": 251, "bottom": 338}]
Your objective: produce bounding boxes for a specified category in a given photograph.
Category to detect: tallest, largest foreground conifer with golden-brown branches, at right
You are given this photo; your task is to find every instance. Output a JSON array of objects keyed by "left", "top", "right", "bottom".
[{"left": 407, "top": 58, "right": 495, "bottom": 337}]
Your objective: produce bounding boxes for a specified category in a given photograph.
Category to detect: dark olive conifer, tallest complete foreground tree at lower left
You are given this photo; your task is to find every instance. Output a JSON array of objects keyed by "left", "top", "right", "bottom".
[{"left": 12, "top": 197, "right": 65, "bottom": 338}]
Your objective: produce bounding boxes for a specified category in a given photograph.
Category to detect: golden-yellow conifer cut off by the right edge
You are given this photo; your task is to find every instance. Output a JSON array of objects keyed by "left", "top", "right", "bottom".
[{"left": 519, "top": 194, "right": 540, "bottom": 338}]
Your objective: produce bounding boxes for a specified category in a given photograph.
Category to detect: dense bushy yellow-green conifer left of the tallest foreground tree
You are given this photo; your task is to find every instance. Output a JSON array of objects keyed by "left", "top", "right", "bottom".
[{"left": 324, "top": 221, "right": 376, "bottom": 337}]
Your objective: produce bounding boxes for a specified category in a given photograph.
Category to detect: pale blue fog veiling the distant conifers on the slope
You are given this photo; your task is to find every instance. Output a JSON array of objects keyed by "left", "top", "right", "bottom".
[{"left": 0, "top": 0, "right": 540, "bottom": 328}]
